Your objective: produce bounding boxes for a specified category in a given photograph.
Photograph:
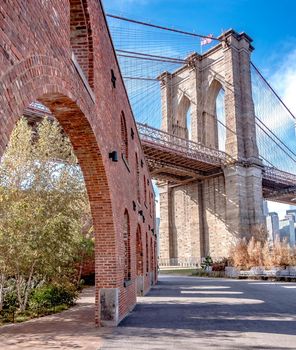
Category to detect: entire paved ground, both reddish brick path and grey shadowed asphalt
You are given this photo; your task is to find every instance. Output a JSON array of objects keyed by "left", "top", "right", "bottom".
[{"left": 0, "top": 276, "right": 296, "bottom": 350}]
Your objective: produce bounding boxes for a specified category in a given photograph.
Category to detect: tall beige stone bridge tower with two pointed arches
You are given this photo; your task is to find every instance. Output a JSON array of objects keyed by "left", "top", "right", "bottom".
[{"left": 159, "top": 30, "right": 264, "bottom": 265}]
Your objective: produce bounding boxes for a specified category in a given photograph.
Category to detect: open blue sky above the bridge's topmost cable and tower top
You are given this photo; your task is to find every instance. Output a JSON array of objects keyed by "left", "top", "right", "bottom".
[{"left": 103, "top": 0, "right": 296, "bottom": 217}]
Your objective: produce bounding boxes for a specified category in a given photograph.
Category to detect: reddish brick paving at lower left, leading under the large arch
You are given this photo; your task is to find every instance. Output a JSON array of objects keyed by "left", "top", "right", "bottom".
[{"left": 0, "top": 288, "right": 106, "bottom": 350}]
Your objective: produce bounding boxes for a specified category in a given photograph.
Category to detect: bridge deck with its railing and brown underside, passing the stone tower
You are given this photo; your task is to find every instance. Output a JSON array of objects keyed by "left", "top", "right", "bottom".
[{"left": 20, "top": 103, "right": 296, "bottom": 204}]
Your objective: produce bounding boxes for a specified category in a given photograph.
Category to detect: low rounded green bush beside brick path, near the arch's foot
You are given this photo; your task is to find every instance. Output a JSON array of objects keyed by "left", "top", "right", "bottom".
[{"left": 29, "top": 284, "right": 78, "bottom": 309}]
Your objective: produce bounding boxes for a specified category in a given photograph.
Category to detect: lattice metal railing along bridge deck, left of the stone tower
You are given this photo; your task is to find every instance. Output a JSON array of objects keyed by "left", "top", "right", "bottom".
[{"left": 137, "top": 123, "right": 235, "bottom": 165}]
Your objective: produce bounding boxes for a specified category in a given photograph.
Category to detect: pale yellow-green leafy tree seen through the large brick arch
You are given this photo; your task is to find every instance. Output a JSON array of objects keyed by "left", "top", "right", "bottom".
[{"left": 0, "top": 118, "right": 90, "bottom": 310}]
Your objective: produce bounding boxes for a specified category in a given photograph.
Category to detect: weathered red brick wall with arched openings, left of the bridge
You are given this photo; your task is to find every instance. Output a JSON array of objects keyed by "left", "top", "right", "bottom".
[{"left": 0, "top": 0, "right": 156, "bottom": 321}]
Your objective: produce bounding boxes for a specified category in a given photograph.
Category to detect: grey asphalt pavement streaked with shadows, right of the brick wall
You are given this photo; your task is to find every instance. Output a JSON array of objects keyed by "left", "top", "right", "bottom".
[{"left": 101, "top": 276, "right": 296, "bottom": 350}]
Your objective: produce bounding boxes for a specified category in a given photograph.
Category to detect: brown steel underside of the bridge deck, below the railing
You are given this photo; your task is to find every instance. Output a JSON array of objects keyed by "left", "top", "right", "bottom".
[{"left": 142, "top": 137, "right": 296, "bottom": 205}]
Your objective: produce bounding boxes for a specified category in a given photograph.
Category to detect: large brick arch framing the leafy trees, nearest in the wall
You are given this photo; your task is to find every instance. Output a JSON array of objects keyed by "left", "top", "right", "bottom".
[{"left": 0, "top": 56, "right": 117, "bottom": 321}]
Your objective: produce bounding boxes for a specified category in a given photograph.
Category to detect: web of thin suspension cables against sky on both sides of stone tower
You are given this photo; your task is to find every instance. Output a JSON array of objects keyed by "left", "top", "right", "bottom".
[{"left": 108, "top": 14, "right": 296, "bottom": 178}]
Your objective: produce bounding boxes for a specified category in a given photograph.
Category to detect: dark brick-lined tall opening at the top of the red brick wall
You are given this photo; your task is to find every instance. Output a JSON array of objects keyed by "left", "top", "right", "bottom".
[{"left": 70, "top": 0, "right": 94, "bottom": 88}]
